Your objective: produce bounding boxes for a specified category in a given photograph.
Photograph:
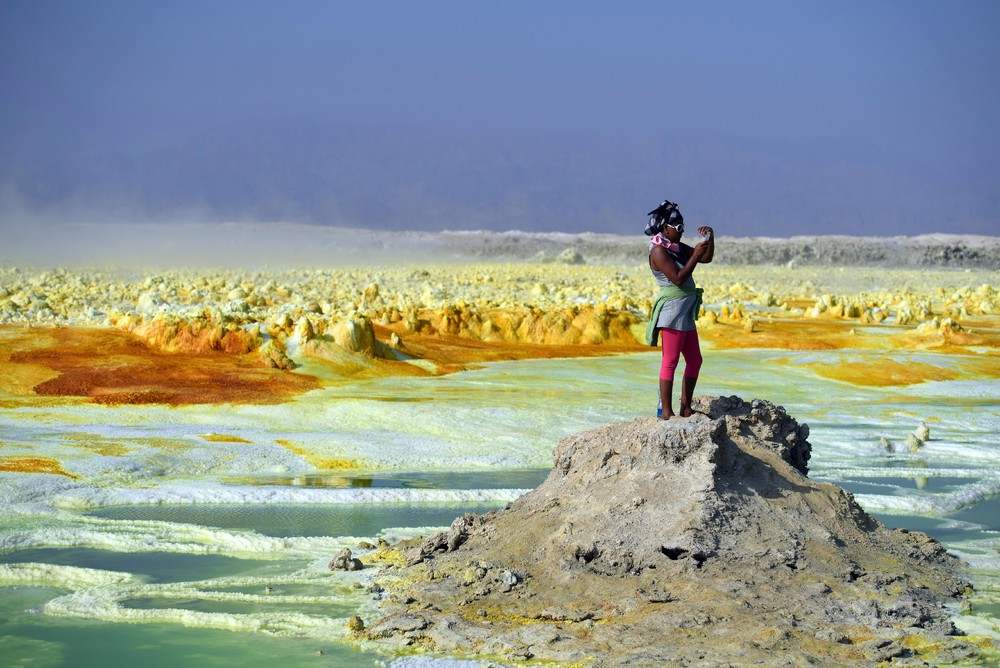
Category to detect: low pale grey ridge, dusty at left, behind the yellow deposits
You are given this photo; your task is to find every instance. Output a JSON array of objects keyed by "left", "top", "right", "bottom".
[{"left": 0, "top": 221, "right": 1000, "bottom": 271}]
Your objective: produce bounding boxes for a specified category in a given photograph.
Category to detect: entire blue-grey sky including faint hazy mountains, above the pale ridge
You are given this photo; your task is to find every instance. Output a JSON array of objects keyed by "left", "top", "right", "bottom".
[{"left": 0, "top": 0, "right": 1000, "bottom": 237}]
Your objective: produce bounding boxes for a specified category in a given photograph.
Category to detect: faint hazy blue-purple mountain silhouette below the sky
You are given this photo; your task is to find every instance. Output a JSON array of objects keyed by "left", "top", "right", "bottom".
[{"left": 0, "top": 120, "right": 1000, "bottom": 236}]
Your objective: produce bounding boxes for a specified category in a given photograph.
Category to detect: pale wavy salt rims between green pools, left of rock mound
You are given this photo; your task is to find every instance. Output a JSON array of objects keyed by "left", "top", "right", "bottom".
[{"left": 0, "top": 532, "right": 410, "bottom": 640}]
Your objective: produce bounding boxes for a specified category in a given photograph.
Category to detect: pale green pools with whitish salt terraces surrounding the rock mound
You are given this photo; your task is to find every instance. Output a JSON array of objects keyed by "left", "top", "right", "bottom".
[{"left": 0, "top": 351, "right": 1000, "bottom": 666}]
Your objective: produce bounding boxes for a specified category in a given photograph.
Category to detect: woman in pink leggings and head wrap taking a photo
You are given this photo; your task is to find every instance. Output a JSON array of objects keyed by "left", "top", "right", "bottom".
[{"left": 646, "top": 200, "right": 715, "bottom": 420}]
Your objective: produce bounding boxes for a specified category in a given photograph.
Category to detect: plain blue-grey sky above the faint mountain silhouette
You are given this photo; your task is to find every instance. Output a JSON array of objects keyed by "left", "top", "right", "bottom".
[{"left": 0, "top": 0, "right": 1000, "bottom": 231}]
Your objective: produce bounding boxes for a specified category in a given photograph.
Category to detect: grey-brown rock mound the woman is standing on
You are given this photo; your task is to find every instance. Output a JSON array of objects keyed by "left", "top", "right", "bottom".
[{"left": 366, "top": 397, "right": 968, "bottom": 665}]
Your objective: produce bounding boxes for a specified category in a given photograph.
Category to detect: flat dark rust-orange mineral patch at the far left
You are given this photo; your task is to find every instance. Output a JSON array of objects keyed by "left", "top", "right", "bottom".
[{"left": 0, "top": 327, "right": 319, "bottom": 406}]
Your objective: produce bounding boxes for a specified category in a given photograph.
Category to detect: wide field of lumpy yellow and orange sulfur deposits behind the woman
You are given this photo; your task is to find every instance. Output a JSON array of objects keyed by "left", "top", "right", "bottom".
[{"left": 0, "top": 262, "right": 1000, "bottom": 403}]
